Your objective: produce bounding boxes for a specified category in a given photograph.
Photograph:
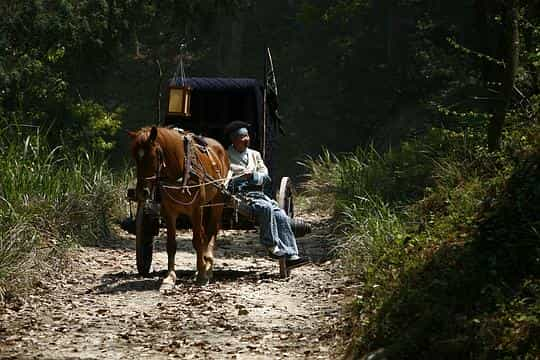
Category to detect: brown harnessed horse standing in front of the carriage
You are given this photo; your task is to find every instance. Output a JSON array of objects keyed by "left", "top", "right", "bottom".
[{"left": 129, "top": 126, "right": 229, "bottom": 290}]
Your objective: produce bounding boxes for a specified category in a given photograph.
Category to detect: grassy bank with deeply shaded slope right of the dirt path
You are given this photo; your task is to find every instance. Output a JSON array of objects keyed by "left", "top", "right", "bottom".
[{"left": 304, "top": 116, "right": 540, "bottom": 359}]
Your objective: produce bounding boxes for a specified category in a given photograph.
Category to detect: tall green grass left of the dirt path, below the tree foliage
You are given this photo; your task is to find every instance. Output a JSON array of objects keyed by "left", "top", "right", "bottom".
[{"left": 0, "top": 126, "right": 127, "bottom": 300}]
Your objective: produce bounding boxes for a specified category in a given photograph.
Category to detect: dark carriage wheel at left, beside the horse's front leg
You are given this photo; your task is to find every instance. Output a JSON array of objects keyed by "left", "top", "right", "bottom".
[{"left": 135, "top": 202, "right": 159, "bottom": 276}]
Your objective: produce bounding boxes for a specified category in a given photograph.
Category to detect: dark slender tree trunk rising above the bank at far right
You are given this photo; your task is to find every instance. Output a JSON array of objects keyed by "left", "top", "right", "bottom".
[{"left": 488, "top": 0, "right": 519, "bottom": 151}]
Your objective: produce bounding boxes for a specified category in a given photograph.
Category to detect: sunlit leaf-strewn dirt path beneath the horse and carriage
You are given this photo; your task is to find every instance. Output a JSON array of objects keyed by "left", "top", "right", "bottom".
[{"left": 0, "top": 215, "right": 350, "bottom": 359}]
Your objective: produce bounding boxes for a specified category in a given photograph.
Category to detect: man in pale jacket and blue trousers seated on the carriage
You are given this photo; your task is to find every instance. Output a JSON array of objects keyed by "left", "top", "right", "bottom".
[{"left": 225, "top": 121, "right": 308, "bottom": 268}]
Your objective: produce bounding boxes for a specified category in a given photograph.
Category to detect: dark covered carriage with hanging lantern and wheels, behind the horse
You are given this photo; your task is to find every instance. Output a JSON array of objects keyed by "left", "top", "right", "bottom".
[{"left": 123, "top": 52, "right": 309, "bottom": 275}]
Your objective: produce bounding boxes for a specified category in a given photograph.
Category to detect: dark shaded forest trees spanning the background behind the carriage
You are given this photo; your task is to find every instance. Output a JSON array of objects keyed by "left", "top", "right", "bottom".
[{"left": 0, "top": 0, "right": 540, "bottom": 171}]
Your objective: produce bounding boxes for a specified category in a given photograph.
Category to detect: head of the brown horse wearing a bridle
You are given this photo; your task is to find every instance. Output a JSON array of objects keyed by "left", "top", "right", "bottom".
[{"left": 128, "top": 126, "right": 163, "bottom": 201}]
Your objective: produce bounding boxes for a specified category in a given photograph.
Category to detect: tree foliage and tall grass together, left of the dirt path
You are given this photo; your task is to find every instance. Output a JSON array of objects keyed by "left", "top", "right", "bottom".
[{"left": 0, "top": 0, "right": 132, "bottom": 300}]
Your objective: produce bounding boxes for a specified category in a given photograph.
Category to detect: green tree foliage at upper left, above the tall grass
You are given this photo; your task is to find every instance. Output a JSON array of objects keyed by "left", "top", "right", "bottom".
[{"left": 0, "top": 0, "right": 129, "bottom": 156}]
